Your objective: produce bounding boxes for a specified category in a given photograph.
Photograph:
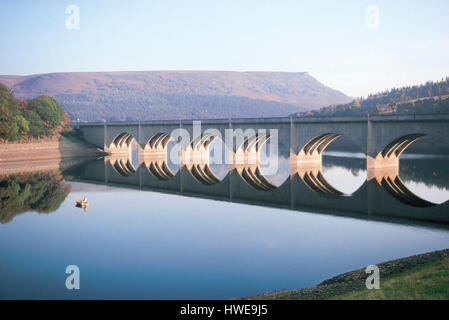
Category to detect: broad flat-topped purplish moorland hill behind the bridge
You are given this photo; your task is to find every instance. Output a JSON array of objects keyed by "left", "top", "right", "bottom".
[{"left": 0, "top": 71, "right": 351, "bottom": 121}]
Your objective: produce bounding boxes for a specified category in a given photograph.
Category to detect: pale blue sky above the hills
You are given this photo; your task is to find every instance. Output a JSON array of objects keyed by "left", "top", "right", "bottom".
[{"left": 0, "top": 0, "right": 449, "bottom": 96}]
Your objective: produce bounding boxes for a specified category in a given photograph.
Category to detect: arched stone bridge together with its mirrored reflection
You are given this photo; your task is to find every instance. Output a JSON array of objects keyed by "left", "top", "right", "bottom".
[{"left": 80, "top": 115, "right": 449, "bottom": 222}]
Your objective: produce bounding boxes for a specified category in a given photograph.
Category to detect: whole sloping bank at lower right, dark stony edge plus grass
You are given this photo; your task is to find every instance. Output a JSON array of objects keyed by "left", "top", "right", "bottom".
[{"left": 243, "top": 249, "right": 449, "bottom": 300}]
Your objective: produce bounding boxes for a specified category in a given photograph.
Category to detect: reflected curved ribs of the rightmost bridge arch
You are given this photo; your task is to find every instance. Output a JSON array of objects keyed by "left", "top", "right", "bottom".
[{"left": 380, "top": 175, "right": 436, "bottom": 208}]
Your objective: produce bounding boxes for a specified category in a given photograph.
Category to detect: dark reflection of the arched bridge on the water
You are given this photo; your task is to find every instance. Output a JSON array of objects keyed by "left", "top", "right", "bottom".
[{"left": 74, "top": 157, "right": 449, "bottom": 223}]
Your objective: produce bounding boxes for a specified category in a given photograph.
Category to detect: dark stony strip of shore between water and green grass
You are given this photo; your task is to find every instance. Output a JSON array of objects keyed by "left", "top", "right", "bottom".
[{"left": 236, "top": 249, "right": 449, "bottom": 300}]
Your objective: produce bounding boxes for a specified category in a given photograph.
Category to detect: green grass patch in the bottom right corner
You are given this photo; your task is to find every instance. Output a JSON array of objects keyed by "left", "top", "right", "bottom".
[{"left": 332, "top": 257, "right": 449, "bottom": 300}]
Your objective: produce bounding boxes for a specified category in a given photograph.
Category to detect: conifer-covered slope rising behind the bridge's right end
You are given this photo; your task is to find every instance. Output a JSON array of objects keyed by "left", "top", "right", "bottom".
[{"left": 295, "top": 77, "right": 449, "bottom": 117}]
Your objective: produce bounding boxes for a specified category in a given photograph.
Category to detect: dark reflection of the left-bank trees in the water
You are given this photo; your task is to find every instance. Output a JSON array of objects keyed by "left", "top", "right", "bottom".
[{"left": 0, "top": 171, "right": 70, "bottom": 223}]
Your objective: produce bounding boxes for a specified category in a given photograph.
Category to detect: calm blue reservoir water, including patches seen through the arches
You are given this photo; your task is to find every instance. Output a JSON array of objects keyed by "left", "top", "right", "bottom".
[{"left": 0, "top": 153, "right": 449, "bottom": 299}]
